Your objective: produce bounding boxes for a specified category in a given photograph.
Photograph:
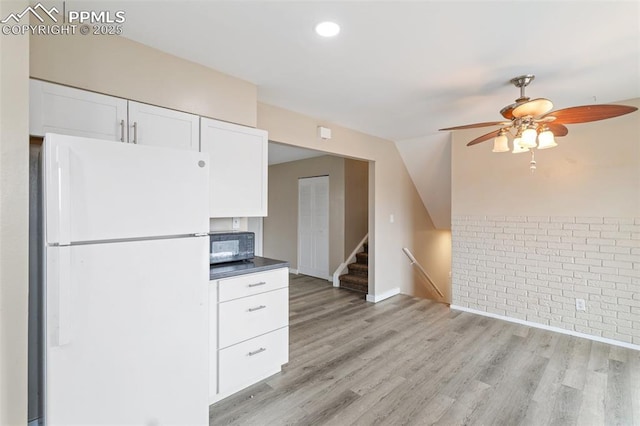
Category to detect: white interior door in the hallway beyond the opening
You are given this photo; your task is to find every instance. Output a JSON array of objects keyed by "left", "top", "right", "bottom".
[{"left": 298, "top": 176, "right": 329, "bottom": 280}]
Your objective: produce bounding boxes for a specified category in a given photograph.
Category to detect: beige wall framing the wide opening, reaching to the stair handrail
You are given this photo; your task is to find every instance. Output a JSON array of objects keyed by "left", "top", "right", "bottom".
[{"left": 258, "top": 103, "right": 450, "bottom": 302}]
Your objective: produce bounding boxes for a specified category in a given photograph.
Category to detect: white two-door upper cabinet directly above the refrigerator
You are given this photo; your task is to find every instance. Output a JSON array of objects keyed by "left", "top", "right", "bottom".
[{"left": 29, "top": 80, "right": 200, "bottom": 151}]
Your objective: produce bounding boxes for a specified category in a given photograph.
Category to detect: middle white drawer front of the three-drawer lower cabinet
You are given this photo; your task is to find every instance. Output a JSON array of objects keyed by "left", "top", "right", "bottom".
[{"left": 218, "top": 288, "right": 289, "bottom": 348}]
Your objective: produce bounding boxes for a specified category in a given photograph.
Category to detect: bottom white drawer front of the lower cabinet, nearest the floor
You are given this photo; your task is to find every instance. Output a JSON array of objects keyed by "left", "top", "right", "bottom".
[{"left": 218, "top": 327, "right": 289, "bottom": 394}]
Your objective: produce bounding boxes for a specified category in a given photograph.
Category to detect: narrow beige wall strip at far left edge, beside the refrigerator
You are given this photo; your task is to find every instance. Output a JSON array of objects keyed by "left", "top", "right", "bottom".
[{"left": 0, "top": 1, "right": 29, "bottom": 425}]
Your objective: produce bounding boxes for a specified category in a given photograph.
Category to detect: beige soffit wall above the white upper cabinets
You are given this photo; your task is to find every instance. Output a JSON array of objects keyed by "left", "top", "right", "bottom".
[{"left": 30, "top": 35, "right": 257, "bottom": 127}]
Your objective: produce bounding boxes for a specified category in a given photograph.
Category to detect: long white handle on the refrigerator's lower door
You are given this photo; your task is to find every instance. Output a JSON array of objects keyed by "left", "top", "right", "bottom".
[{"left": 47, "top": 247, "right": 71, "bottom": 347}]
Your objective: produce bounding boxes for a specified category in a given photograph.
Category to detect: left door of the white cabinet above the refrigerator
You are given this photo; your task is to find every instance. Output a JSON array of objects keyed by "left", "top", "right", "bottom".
[{"left": 29, "top": 80, "right": 127, "bottom": 142}]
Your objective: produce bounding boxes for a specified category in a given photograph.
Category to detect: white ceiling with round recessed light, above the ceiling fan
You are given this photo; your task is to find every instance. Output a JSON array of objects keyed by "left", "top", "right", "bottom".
[{"left": 95, "top": 0, "right": 640, "bottom": 226}]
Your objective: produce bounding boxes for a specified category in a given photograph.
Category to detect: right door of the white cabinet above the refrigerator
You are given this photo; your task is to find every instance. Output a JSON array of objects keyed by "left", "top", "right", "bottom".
[{"left": 129, "top": 101, "right": 200, "bottom": 151}]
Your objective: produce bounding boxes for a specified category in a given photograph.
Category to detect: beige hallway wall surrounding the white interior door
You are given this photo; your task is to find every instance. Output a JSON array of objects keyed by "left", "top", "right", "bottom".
[{"left": 263, "top": 155, "right": 345, "bottom": 278}]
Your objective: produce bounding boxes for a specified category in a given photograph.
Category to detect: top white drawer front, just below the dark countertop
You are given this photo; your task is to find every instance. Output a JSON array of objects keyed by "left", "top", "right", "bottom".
[{"left": 218, "top": 268, "right": 289, "bottom": 302}]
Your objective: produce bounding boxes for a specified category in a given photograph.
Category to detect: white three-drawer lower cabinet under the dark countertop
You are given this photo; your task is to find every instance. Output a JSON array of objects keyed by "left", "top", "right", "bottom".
[{"left": 209, "top": 268, "right": 289, "bottom": 403}]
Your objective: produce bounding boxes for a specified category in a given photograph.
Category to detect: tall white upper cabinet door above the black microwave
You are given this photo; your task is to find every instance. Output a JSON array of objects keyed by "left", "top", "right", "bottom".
[{"left": 200, "top": 118, "right": 268, "bottom": 217}]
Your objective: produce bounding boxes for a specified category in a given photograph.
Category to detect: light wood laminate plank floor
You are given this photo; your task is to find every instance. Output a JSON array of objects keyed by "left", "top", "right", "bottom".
[{"left": 210, "top": 275, "right": 640, "bottom": 425}]
